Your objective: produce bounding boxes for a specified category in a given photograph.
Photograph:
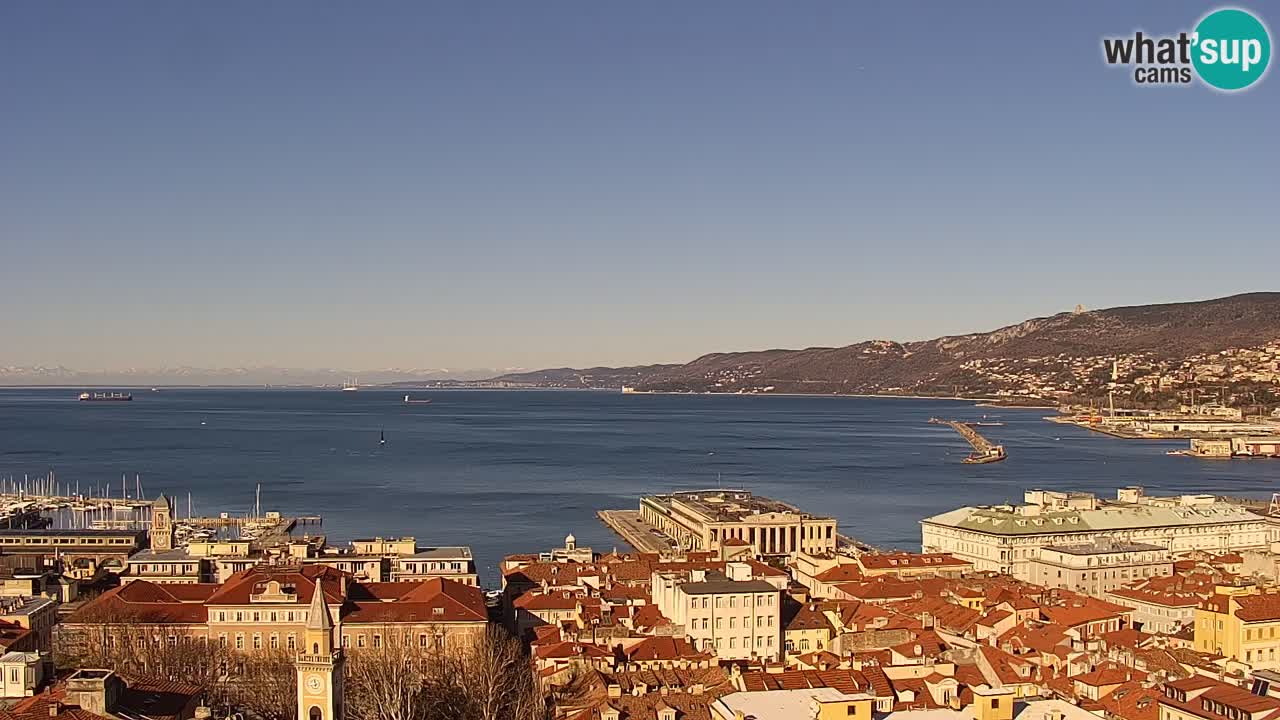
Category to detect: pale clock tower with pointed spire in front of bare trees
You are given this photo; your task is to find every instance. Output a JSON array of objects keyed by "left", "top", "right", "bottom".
[{"left": 294, "top": 578, "right": 344, "bottom": 720}]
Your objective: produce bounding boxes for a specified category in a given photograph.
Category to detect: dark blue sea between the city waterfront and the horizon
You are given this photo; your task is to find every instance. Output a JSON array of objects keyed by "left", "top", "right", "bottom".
[{"left": 0, "top": 389, "right": 1280, "bottom": 583}]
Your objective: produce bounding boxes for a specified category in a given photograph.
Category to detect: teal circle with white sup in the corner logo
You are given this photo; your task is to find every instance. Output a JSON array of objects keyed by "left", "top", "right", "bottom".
[{"left": 1192, "top": 8, "right": 1271, "bottom": 91}]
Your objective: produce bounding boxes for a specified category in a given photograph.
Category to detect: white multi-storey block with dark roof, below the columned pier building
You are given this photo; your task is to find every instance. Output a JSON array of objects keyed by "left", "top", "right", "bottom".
[{"left": 650, "top": 562, "right": 782, "bottom": 660}]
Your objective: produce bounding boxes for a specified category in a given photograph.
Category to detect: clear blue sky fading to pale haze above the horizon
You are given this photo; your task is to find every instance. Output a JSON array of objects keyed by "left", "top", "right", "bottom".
[{"left": 0, "top": 0, "right": 1280, "bottom": 369}]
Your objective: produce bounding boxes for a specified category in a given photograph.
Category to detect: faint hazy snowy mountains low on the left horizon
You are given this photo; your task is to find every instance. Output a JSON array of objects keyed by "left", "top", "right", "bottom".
[{"left": 0, "top": 366, "right": 502, "bottom": 387}]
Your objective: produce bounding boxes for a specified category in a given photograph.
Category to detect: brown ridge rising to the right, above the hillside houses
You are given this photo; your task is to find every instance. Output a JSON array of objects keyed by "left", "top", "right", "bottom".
[{"left": 490, "top": 292, "right": 1280, "bottom": 395}]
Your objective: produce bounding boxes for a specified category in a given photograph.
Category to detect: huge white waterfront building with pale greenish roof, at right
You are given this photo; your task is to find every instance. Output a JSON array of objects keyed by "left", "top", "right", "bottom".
[{"left": 920, "top": 487, "right": 1272, "bottom": 580}]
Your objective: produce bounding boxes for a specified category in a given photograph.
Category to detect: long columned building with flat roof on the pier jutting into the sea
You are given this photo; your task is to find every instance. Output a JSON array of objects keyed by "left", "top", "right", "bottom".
[{"left": 640, "top": 489, "right": 837, "bottom": 556}]
